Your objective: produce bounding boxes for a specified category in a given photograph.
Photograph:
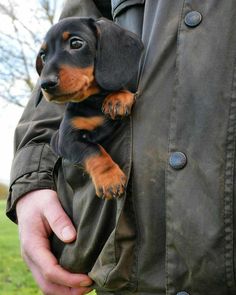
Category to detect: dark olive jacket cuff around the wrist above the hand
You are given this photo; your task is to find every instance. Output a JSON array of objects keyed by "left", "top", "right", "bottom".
[{"left": 6, "top": 144, "right": 58, "bottom": 222}]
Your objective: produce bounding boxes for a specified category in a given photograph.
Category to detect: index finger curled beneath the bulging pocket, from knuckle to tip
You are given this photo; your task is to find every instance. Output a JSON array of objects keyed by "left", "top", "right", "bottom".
[{"left": 24, "top": 238, "right": 93, "bottom": 288}]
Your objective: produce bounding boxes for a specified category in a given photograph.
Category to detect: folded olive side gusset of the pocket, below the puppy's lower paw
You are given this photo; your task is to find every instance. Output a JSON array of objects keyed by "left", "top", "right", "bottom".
[{"left": 89, "top": 179, "right": 137, "bottom": 292}]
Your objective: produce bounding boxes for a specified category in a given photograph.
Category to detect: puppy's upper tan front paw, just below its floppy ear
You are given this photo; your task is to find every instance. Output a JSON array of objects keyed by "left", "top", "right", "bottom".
[{"left": 102, "top": 90, "right": 135, "bottom": 120}]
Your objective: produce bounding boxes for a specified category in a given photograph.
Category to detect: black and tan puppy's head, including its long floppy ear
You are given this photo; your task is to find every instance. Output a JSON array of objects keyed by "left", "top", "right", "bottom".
[{"left": 36, "top": 17, "right": 143, "bottom": 103}]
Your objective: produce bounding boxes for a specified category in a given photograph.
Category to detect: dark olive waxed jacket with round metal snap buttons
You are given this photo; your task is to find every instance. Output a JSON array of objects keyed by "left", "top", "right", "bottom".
[{"left": 7, "top": 0, "right": 236, "bottom": 295}]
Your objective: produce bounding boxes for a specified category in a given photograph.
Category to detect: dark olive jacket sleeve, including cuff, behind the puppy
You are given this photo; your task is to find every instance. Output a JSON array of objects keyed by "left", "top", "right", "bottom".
[{"left": 6, "top": 0, "right": 109, "bottom": 222}]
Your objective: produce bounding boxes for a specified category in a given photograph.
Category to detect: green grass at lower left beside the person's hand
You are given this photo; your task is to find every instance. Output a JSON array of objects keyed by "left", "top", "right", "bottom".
[{"left": 0, "top": 200, "right": 96, "bottom": 295}]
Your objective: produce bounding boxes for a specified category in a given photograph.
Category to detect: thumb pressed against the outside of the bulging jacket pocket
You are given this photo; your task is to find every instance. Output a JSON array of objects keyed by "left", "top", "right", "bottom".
[{"left": 44, "top": 197, "right": 76, "bottom": 243}]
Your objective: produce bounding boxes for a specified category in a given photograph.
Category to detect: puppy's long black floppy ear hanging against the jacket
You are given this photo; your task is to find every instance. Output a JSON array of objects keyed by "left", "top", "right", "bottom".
[{"left": 95, "top": 19, "right": 143, "bottom": 91}]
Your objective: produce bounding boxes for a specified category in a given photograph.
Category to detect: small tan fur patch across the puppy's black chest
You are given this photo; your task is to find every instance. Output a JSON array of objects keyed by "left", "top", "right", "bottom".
[{"left": 71, "top": 116, "right": 104, "bottom": 131}]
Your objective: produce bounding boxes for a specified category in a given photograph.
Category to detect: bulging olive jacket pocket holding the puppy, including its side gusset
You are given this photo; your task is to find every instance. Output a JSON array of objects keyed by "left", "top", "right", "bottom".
[{"left": 51, "top": 118, "right": 136, "bottom": 291}]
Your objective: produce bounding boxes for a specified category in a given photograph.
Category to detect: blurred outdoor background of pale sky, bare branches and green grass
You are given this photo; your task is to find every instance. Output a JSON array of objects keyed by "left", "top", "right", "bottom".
[{"left": 0, "top": 0, "right": 63, "bottom": 295}]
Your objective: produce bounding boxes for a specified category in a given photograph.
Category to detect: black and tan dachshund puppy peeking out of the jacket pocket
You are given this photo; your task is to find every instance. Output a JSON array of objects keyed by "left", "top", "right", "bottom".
[{"left": 36, "top": 18, "right": 143, "bottom": 199}]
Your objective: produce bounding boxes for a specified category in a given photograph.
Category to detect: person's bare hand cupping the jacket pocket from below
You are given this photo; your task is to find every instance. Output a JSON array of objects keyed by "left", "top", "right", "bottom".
[{"left": 16, "top": 189, "right": 92, "bottom": 295}]
